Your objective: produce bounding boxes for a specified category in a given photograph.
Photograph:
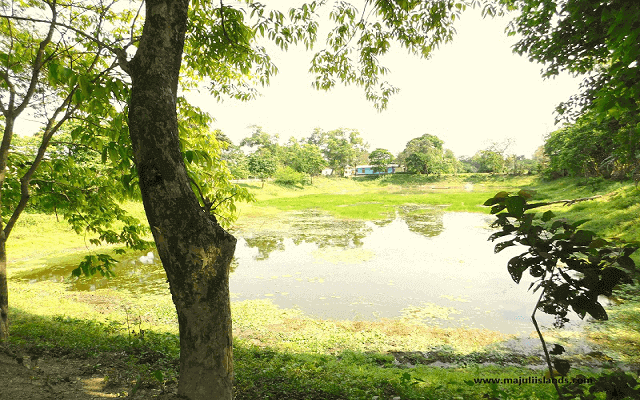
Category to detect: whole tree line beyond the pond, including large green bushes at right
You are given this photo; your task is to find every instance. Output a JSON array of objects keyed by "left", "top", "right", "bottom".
[{"left": 224, "top": 112, "right": 640, "bottom": 184}]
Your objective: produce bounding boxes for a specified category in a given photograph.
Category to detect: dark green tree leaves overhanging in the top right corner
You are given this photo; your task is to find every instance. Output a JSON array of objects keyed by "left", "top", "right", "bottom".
[{"left": 501, "top": 0, "right": 640, "bottom": 128}]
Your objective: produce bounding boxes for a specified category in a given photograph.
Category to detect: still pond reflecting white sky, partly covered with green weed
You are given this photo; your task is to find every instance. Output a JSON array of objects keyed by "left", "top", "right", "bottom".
[{"left": 20, "top": 206, "right": 580, "bottom": 333}]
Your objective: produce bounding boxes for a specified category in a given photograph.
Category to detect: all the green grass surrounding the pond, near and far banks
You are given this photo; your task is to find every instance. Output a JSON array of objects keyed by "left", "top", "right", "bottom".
[{"left": 8, "top": 175, "right": 640, "bottom": 400}]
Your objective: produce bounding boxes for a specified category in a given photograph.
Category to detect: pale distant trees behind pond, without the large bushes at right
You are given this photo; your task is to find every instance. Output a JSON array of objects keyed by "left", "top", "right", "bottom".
[{"left": 218, "top": 126, "right": 544, "bottom": 185}]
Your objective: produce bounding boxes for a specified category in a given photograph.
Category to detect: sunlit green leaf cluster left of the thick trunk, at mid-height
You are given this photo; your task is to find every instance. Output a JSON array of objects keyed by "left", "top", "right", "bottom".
[{"left": 3, "top": 134, "right": 150, "bottom": 276}]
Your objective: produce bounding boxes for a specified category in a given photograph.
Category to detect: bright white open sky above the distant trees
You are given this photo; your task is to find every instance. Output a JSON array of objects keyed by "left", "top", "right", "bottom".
[{"left": 194, "top": 10, "right": 580, "bottom": 157}]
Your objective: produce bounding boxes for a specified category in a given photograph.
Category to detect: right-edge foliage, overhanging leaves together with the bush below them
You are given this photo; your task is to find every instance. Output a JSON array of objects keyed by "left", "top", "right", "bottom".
[{"left": 500, "top": 0, "right": 640, "bottom": 183}]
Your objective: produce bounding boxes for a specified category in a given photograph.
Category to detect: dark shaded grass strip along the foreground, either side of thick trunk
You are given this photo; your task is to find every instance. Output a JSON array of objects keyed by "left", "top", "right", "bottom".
[{"left": 5, "top": 309, "right": 564, "bottom": 400}]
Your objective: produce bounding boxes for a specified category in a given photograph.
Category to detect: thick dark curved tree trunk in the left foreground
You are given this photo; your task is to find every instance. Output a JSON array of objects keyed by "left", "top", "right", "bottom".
[{"left": 125, "top": 0, "right": 236, "bottom": 400}]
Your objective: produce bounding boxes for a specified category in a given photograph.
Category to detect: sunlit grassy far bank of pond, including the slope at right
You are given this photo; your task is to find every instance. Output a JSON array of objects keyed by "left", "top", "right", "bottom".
[{"left": 238, "top": 174, "right": 640, "bottom": 247}]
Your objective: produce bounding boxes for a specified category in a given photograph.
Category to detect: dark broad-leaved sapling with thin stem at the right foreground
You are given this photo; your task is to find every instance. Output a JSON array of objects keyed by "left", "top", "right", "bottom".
[{"left": 484, "top": 190, "right": 640, "bottom": 399}]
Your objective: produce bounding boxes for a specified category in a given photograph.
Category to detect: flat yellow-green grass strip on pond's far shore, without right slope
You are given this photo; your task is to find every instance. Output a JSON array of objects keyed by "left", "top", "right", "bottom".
[{"left": 239, "top": 174, "right": 534, "bottom": 219}]
